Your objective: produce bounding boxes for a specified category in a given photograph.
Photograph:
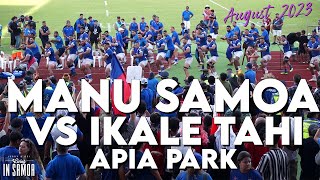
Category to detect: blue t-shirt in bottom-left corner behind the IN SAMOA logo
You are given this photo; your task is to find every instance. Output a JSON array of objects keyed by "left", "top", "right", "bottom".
[{"left": 0, "top": 146, "right": 19, "bottom": 180}]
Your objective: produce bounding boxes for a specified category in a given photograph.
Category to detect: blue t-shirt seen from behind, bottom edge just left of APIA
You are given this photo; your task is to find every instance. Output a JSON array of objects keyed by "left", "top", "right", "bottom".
[{"left": 46, "top": 153, "right": 85, "bottom": 180}]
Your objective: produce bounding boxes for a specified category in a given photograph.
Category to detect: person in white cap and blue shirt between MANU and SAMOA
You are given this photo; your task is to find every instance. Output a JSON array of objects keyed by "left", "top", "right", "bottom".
[{"left": 140, "top": 78, "right": 155, "bottom": 114}]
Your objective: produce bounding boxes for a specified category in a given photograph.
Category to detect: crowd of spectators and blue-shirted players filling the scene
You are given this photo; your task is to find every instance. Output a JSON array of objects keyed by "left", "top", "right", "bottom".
[{"left": 0, "top": 3, "right": 320, "bottom": 180}]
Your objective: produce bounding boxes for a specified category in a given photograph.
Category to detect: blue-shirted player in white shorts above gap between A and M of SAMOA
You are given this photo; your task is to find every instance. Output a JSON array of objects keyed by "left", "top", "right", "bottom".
[{"left": 207, "top": 35, "right": 219, "bottom": 76}]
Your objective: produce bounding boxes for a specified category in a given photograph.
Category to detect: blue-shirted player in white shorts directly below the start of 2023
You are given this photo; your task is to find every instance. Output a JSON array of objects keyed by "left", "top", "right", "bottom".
[{"left": 278, "top": 35, "right": 293, "bottom": 74}]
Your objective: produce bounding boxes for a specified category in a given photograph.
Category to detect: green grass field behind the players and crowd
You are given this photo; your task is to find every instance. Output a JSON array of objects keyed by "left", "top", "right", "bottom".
[{"left": 0, "top": 0, "right": 320, "bottom": 81}]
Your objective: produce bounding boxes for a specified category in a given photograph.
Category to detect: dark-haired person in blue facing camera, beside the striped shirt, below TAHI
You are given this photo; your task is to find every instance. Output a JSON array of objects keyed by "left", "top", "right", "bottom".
[{"left": 230, "top": 151, "right": 263, "bottom": 180}]
